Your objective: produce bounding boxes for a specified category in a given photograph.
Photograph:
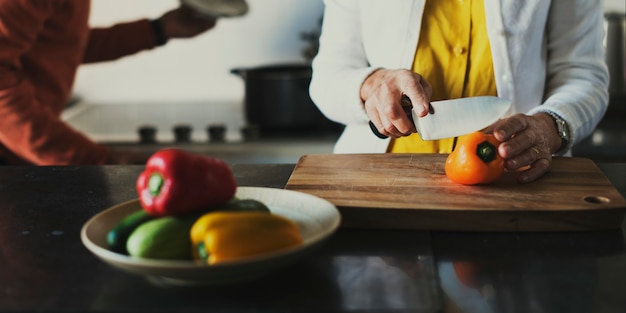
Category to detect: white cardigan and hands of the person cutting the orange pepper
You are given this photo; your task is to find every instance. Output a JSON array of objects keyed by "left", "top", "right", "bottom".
[{"left": 310, "top": 0, "right": 609, "bottom": 183}]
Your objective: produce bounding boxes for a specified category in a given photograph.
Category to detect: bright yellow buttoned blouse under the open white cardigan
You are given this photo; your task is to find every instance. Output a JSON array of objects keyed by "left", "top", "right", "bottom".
[{"left": 387, "top": 0, "right": 497, "bottom": 153}]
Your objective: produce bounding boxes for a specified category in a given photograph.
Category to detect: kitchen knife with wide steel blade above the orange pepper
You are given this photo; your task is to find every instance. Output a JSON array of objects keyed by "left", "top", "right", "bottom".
[{"left": 370, "top": 96, "right": 511, "bottom": 140}]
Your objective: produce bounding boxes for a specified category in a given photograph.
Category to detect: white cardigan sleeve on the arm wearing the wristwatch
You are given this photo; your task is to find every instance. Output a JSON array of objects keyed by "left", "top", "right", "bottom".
[{"left": 530, "top": 0, "right": 608, "bottom": 147}]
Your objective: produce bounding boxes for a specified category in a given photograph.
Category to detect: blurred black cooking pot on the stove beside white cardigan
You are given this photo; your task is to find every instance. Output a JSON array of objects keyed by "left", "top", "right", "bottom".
[{"left": 231, "top": 64, "right": 328, "bottom": 130}]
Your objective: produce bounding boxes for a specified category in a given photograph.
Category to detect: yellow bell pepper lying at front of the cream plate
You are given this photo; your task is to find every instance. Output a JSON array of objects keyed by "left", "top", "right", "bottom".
[{"left": 190, "top": 212, "right": 303, "bottom": 264}]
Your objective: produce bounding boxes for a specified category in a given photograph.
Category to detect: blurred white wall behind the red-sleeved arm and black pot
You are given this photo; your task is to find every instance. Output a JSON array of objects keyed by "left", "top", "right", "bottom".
[{"left": 74, "top": 0, "right": 323, "bottom": 103}]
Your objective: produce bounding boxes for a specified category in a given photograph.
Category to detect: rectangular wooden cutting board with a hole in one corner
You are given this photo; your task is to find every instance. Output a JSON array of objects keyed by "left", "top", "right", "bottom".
[{"left": 285, "top": 154, "right": 626, "bottom": 231}]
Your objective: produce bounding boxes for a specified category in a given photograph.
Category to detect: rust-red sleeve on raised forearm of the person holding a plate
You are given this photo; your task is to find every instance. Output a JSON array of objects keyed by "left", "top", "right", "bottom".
[{"left": 83, "top": 19, "right": 156, "bottom": 63}]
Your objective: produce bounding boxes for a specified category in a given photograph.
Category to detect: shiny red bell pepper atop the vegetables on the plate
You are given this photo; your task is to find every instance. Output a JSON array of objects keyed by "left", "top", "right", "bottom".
[{"left": 137, "top": 149, "right": 237, "bottom": 216}]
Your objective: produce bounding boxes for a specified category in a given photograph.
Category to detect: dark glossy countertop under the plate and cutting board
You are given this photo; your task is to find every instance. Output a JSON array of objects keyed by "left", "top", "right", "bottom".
[{"left": 0, "top": 163, "right": 626, "bottom": 313}]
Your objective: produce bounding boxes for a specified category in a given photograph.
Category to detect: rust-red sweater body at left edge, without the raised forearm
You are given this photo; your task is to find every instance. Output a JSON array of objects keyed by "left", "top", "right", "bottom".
[{"left": 0, "top": 0, "right": 107, "bottom": 165}]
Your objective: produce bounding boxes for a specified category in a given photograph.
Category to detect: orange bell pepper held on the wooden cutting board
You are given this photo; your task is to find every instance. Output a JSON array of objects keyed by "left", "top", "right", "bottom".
[{"left": 445, "top": 132, "right": 504, "bottom": 185}]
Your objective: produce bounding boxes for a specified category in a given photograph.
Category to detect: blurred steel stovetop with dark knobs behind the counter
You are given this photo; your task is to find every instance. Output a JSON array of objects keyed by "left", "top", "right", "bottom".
[{"left": 62, "top": 103, "right": 341, "bottom": 163}]
